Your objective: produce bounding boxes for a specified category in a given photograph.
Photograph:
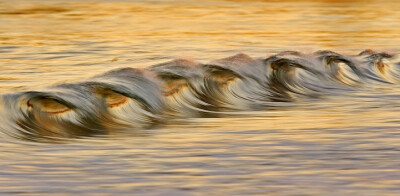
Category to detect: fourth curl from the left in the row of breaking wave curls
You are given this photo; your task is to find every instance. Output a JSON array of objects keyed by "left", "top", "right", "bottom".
[{"left": 203, "top": 54, "right": 268, "bottom": 110}]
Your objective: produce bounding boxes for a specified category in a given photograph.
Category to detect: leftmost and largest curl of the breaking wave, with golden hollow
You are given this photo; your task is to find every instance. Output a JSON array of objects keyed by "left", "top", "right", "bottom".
[{"left": 1, "top": 84, "right": 104, "bottom": 138}]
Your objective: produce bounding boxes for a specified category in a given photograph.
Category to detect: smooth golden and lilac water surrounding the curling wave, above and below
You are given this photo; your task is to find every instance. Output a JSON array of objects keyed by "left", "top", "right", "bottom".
[{"left": 0, "top": 0, "right": 400, "bottom": 195}]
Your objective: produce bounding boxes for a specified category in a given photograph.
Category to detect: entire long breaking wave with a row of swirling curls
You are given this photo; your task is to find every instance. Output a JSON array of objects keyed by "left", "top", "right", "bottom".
[{"left": 0, "top": 50, "right": 400, "bottom": 140}]
